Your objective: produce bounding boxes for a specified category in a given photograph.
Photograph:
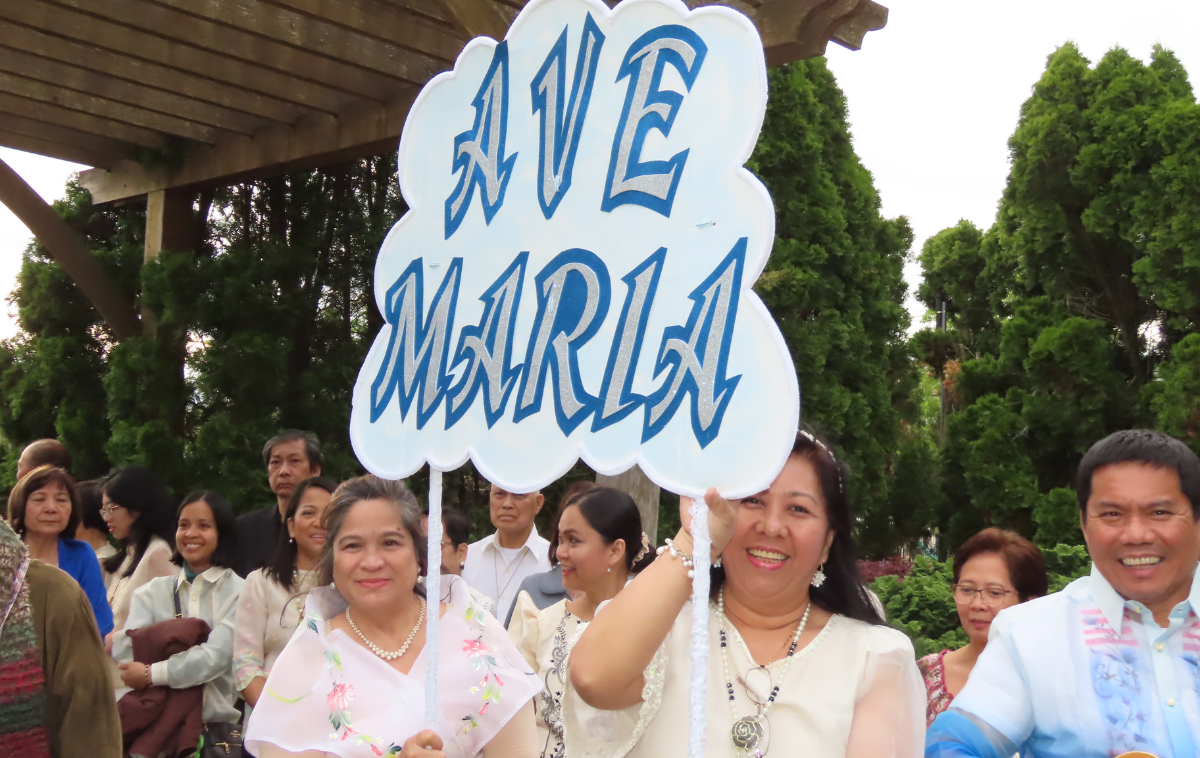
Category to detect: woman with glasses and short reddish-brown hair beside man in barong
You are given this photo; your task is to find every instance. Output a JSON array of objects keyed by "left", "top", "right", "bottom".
[{"left": 917, "top": 528, "right": 1048, "bottom": 723}]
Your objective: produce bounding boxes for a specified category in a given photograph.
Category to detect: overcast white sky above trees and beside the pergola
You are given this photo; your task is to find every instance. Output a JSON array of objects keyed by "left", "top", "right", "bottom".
[{"left": 0, "top": 0, "right": 1200, "bottom": 338}]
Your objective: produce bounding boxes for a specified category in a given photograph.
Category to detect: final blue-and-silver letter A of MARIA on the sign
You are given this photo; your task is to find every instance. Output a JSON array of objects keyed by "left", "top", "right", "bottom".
[{"left": 642, "top": 237, "right": 746, "bottom": 447}]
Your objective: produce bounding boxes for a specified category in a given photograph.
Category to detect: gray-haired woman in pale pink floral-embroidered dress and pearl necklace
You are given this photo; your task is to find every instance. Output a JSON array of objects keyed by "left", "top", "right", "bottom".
[{"left": 246, "top": 476, "right": 541, "bottom": 758}]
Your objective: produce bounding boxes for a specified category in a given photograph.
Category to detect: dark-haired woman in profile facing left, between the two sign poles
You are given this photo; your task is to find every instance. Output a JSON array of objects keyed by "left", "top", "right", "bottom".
[{"left": 509, "top": 487, "right": 649, "bottom": 758}]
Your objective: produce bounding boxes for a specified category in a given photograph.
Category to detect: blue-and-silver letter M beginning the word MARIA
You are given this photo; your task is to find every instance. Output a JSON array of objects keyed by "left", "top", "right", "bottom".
[{"left": 371, "top": 258, "right": 462, "bottom": 429}]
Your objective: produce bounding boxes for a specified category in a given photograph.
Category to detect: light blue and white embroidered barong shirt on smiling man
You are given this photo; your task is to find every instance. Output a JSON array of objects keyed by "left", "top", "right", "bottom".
[{"left": 925, "top": 565, "right": 1200, "bottom": 758}]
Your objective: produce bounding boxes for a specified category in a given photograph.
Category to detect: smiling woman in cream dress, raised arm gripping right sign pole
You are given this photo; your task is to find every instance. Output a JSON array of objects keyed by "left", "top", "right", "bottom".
[{"left": 566, "top": 431, "right": 925, "bottom": 758}]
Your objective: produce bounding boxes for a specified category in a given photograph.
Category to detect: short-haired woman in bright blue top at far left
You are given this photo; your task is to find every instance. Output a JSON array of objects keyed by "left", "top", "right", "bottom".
[{"left": 8, "top": 465, "right": 113, "bottom": 637}]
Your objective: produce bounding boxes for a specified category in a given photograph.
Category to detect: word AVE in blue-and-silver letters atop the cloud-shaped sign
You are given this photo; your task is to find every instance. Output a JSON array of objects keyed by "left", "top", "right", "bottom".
[{"left": 445, "top": 13, "right": 708, "bottom": 240}]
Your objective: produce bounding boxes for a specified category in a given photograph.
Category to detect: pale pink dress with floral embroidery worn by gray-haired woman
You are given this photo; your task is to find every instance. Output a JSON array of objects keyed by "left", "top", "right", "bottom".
[{"left": 246, "top": 577, "right": 541, "bottom": 758}]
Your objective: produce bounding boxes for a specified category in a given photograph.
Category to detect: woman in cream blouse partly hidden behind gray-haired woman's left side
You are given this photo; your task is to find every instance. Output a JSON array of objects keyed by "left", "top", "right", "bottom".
[{"left": 233, "top": 476, "right": 337, "bottom": 708}]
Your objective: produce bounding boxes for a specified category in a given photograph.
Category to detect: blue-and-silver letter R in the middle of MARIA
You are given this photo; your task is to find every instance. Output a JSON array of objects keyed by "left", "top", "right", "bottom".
[{"left": 512, "top": 248, "right": 612, "bottom": 435}]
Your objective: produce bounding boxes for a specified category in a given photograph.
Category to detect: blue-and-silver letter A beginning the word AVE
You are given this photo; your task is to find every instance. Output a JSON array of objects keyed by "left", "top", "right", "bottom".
[{"left": 445, "top": 41, "right": 517, "bottom": 240}]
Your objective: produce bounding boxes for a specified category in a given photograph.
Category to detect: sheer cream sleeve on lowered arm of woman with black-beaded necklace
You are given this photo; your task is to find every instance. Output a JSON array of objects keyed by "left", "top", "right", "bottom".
[{"left": 846, "top": 627, "right": 925, "bottom": 758}]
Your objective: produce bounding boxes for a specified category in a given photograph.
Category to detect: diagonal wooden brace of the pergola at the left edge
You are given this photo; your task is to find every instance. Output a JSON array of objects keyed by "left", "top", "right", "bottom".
[{"left": 0, "top": 161, "right": 140, "bottom": 339}]
